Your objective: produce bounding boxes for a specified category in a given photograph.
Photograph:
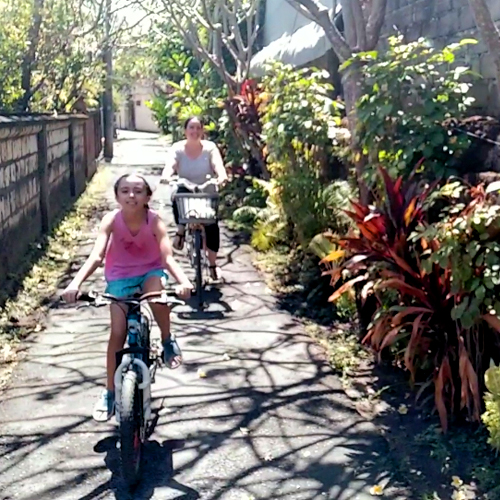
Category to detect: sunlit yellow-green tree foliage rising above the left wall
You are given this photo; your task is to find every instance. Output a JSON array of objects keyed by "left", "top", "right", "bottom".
[{"left": 0, "top": 0, "right": 148, "bottom": 112}]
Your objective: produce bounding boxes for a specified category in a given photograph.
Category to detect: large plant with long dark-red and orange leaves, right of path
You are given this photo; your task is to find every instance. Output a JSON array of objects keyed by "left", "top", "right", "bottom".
[{"left": 322, "top": 169, "right": 498, "bottom": 431}]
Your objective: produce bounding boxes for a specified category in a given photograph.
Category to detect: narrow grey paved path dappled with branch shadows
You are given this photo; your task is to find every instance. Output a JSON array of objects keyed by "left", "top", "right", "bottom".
[{"left": 0, "top": 132, "right": 396, "bottom": 500}]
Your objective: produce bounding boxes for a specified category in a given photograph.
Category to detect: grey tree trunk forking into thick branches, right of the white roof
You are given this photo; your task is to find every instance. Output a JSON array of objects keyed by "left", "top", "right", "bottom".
[{"left": 287, "top": 0, "right": 387, "bottom": 201}]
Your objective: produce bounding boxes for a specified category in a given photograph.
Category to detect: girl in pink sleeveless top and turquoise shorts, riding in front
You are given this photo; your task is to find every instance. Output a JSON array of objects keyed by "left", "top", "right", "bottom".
[{"left": 62, "top": 174, "right": 193, "bottom": 421}]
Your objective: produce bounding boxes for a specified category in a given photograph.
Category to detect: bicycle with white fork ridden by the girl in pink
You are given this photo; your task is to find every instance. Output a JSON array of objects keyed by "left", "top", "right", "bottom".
[{"left": 78, "top": 290, "right": 184, "bottom": 488}]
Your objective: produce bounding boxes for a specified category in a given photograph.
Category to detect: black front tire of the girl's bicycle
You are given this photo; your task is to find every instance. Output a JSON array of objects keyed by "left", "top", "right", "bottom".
[{"left": 120, "top": 370, "right": 143, "bottom": 488}]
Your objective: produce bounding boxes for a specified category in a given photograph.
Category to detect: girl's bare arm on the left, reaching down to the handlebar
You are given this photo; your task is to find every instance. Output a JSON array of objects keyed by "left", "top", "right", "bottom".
[{"left": 62, "top": 212, "right": 116, "bottom": 303}]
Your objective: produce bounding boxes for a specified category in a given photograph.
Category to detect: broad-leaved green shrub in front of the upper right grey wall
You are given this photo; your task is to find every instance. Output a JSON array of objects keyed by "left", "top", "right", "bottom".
[{"left": 344, "top": 36, "right": 477, "bottom": 183}]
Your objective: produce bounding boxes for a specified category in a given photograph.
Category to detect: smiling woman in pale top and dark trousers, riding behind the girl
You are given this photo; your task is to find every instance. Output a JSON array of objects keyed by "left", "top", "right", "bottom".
[{"left": 161, "top": 116, "right": 227, "bottom": 280}]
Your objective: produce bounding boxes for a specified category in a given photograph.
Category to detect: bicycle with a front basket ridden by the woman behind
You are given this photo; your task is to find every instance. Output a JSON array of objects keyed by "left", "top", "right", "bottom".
[{"left": 170, "top": 179, "right": 220, "bottom": 309}]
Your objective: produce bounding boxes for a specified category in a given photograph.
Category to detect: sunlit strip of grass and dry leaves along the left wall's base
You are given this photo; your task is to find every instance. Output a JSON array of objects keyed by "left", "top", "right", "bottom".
[{"left": 0, "top": 166, "right": 108, "bottom": 388}]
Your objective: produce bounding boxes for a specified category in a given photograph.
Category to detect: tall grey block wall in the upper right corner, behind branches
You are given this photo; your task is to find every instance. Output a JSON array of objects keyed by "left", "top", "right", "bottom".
[{"left": 383, "top": 0, "right": 500, "bottom": 116}]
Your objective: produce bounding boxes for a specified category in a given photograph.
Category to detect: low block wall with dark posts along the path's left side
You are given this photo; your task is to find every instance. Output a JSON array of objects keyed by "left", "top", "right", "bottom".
[{"left": 0, "top": 113, "right": 101, "bottom": 288}]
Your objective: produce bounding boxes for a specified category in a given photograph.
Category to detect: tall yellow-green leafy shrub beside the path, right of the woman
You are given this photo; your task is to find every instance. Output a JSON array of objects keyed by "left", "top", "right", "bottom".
[{"left": 255, "top": 63, "right": 352, "bottom": 249}]
